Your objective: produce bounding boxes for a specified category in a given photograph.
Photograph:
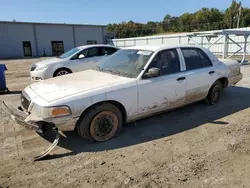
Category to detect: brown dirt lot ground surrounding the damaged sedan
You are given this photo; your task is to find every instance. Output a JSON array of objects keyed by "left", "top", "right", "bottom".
[{"left": 0, "top": 59, "right": 250, "bottom": 188}]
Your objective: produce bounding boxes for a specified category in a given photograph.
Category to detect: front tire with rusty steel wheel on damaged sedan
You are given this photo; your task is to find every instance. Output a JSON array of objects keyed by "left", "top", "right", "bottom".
[{"left": 76, "top": 103, "right": 123, "bottom": 142}]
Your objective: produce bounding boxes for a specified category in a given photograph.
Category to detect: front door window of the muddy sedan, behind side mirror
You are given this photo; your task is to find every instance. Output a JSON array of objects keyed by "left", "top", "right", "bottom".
[{"left": 147, "top": 49, "right": 180, "bottom": 75}]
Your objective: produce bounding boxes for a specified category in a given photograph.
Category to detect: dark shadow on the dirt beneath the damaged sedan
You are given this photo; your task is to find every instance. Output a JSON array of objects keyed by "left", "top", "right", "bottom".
[{"left": 37, "top": 86, "right": 250, "bottom": 159}]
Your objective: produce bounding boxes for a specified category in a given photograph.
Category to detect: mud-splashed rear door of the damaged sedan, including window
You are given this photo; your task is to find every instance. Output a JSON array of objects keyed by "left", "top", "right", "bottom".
[{"left": 181, "top": 48, "right": 217, "bottom": 104}]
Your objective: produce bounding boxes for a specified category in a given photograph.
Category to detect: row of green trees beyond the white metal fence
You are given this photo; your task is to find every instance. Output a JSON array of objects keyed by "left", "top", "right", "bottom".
[{"left": 107, "top": 0, "right": 250, "bottom": 38}]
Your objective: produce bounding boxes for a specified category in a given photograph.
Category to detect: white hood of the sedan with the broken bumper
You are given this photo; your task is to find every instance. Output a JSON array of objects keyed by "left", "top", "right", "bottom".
[{"left": 30, "top": 70, "right": 131, "bottom": 102}]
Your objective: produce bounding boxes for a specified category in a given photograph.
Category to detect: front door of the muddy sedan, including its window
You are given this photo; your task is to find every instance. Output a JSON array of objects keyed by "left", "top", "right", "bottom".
[{"left": 138, "top": 49, "right": 187, "bottom": 117}]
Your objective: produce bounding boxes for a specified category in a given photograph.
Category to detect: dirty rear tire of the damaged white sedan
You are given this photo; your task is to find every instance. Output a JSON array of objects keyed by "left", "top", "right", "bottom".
[{"left": 205, "top": 81, "right": 223, "bottom": 105}]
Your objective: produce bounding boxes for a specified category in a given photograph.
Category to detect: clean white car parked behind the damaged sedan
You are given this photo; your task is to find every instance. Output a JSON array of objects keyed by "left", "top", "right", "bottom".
[{"left": 30, "top": 44, "right": 119, "bottom": 81}]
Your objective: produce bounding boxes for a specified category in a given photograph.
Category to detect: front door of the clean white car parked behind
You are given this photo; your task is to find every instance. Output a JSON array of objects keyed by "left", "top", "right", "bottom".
[{"left": 70, "top": 47, "right": 101, "bottom": 72}]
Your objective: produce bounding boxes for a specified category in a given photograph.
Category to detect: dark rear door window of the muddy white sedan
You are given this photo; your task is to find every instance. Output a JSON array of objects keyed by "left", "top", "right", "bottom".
[{"left": 181, "top": 48, "right": 212, "bottom": 70}]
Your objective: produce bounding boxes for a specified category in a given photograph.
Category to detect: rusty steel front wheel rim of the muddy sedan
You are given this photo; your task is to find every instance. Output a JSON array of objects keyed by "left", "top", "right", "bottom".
[{"left": 90, "top": 111, "right": 118, "bottom": 141}]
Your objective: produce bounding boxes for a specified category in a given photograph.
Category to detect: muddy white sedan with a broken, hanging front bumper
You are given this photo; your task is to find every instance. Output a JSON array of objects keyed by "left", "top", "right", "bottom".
[{"left": 4, "top": 46, "right": 242, "bottom": 141}]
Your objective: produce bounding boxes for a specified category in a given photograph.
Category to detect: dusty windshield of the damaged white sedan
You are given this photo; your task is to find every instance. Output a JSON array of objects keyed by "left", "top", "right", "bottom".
[{"left": 98, "top": 49, "right": 153, "bottom": 78}]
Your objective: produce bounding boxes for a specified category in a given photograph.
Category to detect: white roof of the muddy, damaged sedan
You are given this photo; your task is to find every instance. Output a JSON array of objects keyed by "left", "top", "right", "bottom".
[{"left": 122, "top": 44, "right": 205, "bottom": 51}]
